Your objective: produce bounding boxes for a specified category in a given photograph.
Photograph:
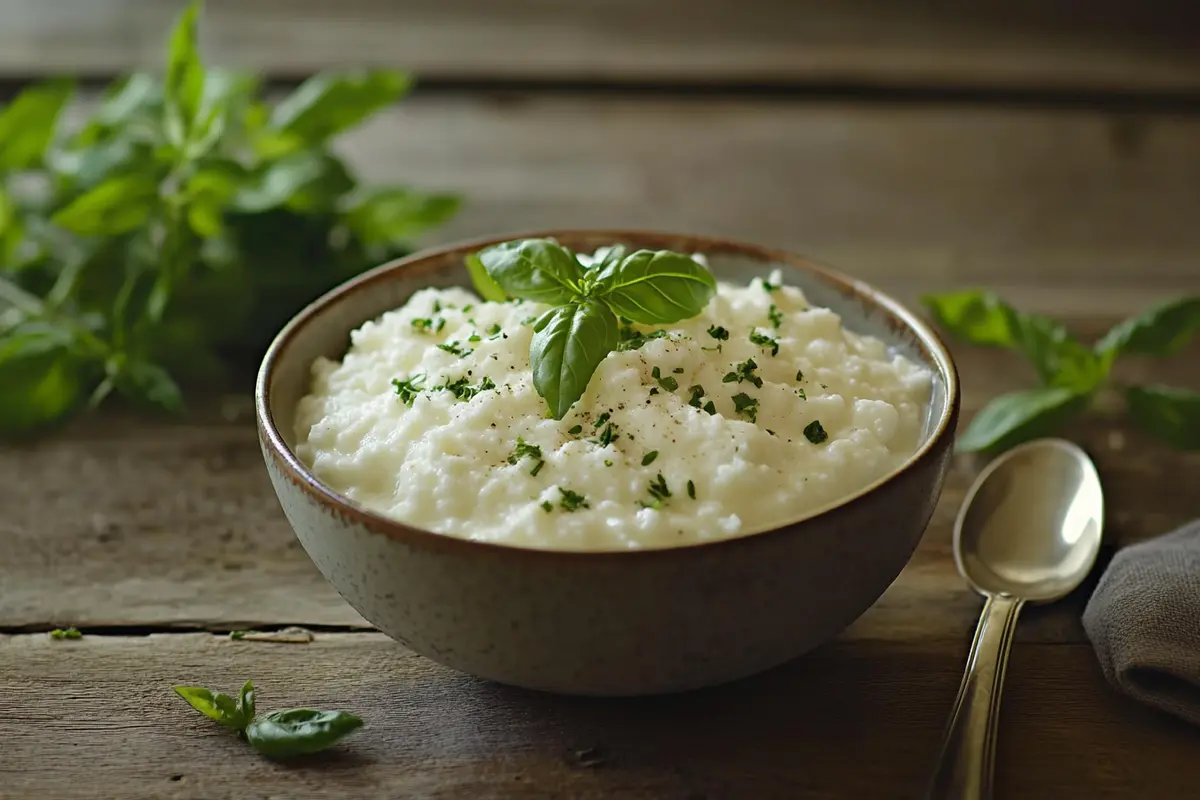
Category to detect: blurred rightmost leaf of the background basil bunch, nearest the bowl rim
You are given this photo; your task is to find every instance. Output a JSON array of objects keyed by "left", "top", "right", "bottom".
[{"left": 344, "top": 187, "right": 462, "bottom": 246}]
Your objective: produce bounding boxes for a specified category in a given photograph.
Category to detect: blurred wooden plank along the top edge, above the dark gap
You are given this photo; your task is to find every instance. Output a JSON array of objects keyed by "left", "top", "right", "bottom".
[{"left": 0, "top": 0, "right": 1200, "bottom": 91}]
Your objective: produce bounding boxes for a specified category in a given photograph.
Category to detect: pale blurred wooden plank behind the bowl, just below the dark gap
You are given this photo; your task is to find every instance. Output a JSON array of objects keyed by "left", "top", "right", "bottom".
[{"left": 344, "top": 96, "right": 1200, "bottom": 315}]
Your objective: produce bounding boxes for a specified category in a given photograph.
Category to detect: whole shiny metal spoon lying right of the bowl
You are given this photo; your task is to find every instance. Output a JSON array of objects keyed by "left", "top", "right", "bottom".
[{"left": 928, "top": 439, "right": 1104, "bottom": 800}]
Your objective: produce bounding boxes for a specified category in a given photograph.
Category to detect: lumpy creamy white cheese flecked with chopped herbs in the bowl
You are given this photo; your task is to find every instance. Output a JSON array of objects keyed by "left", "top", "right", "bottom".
[{"left": 296, "top": 272, "right": 931, "bottom": 551}]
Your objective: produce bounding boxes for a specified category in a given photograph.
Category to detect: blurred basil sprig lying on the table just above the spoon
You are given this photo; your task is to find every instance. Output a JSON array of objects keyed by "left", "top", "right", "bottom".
[{"left": 924, "top": 289, "right": 1200, "bottom": 452}]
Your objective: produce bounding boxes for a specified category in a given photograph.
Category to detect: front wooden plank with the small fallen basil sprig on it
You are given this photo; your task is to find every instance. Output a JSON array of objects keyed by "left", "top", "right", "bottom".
[{"left": 0, "top": 634, "right": 1200, "bottom": 800}]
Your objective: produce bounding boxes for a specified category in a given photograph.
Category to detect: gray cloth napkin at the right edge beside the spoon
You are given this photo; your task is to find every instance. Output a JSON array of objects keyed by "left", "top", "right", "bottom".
[{"left": 1084, "top": 519, "right": 1200, "bottom": 724}]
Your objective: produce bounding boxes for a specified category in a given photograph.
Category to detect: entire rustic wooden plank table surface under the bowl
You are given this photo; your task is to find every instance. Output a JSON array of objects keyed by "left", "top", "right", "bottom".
[{"left": 0, "top": 0, "right": 1200, "bottom": 800}]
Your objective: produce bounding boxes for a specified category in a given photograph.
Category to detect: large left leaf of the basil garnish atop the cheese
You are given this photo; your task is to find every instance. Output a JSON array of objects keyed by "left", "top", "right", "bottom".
[{"left": 476, "top": 239, "right": 583, "bottom": 305}]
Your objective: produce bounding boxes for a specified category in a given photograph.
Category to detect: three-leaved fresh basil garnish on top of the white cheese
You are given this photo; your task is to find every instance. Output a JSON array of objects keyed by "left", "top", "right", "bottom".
[{"left": 467, "top": 239, "right": 716, "bottom": 420}]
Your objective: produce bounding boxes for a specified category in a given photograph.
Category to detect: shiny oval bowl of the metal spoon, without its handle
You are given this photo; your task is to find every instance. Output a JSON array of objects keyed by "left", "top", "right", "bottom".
[{"left": 954, "top": 439, "right": 1104, "bottom": 603}]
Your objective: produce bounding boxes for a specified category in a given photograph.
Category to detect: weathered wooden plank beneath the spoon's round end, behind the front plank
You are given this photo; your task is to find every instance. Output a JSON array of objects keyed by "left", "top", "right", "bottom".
[{"left": 0, "top": 335, "right": 1200, "bottom": 640}]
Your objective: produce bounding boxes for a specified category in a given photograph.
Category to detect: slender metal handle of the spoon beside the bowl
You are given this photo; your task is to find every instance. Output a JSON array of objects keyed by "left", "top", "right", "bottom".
[{"left": 926, "top": 595, "right": 1025, "bottom": 800}]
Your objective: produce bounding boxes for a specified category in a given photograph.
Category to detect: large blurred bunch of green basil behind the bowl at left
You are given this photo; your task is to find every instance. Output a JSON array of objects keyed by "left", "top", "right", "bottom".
[{"left": 0, "top": 4, "right": 460, "bottom": 435}]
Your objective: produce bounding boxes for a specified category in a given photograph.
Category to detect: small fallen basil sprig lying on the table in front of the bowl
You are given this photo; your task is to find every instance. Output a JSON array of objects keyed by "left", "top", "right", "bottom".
[{"left": 174, "top": 680, "right": 362, "bottom": 758}]
